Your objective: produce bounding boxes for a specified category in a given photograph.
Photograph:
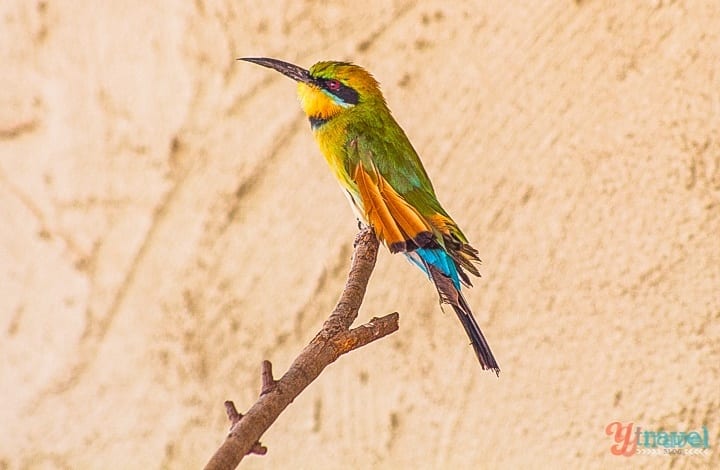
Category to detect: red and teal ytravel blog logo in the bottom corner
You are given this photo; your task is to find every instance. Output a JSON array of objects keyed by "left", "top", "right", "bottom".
[{"left": 605, "top": 421, "right": 710, "bottom": 457}]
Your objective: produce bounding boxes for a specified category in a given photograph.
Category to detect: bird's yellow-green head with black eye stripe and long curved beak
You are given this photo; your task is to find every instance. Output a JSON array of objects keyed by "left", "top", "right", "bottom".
[{"left": 239, "top": 57, "right": 385, "bottom": 123}]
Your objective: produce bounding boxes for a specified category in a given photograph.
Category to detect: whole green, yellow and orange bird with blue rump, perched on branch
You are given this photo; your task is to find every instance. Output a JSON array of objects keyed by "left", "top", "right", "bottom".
[{"left": 240, "top": 58, "right": 500, "bottom": 374}]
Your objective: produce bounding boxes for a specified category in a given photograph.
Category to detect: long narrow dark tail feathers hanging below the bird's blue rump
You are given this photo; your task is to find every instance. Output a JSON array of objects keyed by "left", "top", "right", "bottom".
[{"left": 424, "top": 255, "right": 500, "bottom": 376}]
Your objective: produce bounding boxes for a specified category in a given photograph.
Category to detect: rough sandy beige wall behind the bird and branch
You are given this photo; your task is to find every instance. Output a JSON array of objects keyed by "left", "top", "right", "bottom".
[{"left": 0, "top": 0, "right": 720, "bottom": 469}]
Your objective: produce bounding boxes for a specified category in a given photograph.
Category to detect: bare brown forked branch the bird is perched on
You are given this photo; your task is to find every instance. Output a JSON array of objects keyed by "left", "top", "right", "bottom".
[{"left": 205, "top": 228, "right": 399, "bottom": 470}]
